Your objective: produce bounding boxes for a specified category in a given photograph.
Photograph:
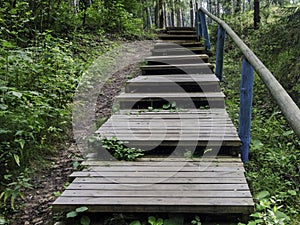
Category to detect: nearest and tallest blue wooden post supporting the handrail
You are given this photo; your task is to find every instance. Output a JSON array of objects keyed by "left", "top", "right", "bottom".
[{"left": 238, "top": 59, "right": 254, "bottom": 163}]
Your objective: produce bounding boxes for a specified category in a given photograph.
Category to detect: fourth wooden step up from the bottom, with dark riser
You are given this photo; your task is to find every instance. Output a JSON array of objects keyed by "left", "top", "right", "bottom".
[{"left": 125, "top": 74, "right": 221, "bottom": 93}]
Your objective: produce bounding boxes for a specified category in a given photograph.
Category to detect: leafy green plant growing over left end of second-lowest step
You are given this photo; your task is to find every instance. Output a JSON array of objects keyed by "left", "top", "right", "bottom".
[{"left": 101, "top": 137, "right": 144, "bottom": 161}]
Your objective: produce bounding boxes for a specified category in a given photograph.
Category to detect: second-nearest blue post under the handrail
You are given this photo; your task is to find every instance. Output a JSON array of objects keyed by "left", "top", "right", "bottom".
[{"left": 216, "top": 25, "right": 226, "bottom": 81}]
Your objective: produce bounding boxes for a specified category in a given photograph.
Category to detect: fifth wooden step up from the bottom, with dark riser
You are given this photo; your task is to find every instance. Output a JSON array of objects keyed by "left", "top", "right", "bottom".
[{"left": 141, "top": 63, "right": 213, "bottom": 75}]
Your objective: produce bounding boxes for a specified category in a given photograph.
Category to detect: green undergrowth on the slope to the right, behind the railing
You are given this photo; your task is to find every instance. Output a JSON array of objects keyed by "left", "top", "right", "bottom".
[{"left": 212, "top": 5, "right": 300, "bottom": 225}]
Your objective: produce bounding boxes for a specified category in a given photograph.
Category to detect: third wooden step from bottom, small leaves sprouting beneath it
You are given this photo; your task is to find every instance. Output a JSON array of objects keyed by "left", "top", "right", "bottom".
[{"left": 116, "top": 91, "right": 225, "bottom": 109}]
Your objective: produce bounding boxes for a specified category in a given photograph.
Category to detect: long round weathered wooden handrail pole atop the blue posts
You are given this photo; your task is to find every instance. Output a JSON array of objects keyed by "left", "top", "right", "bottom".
[{"left": 199, "top": 7, "right": 300, "bottom": 138}]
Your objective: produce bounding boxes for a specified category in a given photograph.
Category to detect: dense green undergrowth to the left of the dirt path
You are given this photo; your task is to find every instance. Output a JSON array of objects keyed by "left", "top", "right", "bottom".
[{"left": 0, "top": 32, "right": 116, "bottom": 221}]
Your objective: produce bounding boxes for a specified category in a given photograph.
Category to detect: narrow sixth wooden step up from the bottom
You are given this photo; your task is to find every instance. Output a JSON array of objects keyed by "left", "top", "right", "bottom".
[{"left": 145, "top": 54, "right": 209, "bottom": 65}]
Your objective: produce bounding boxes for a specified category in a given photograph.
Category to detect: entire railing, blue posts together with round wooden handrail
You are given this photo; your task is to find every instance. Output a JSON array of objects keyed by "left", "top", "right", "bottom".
[{"left": 195, "top": 7, "right": 300, "bottom": 162}]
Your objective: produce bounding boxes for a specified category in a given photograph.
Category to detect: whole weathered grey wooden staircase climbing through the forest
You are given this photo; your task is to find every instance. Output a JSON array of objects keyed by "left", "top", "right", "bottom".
[{"left": 53, "top": 28, "right": 254, "bottom": 222}]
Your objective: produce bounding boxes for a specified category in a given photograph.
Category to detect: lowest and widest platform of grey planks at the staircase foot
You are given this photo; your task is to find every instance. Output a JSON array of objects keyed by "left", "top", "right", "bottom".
[{"left": 54, "top": 158, "right": 253, "bottom": 214}]
